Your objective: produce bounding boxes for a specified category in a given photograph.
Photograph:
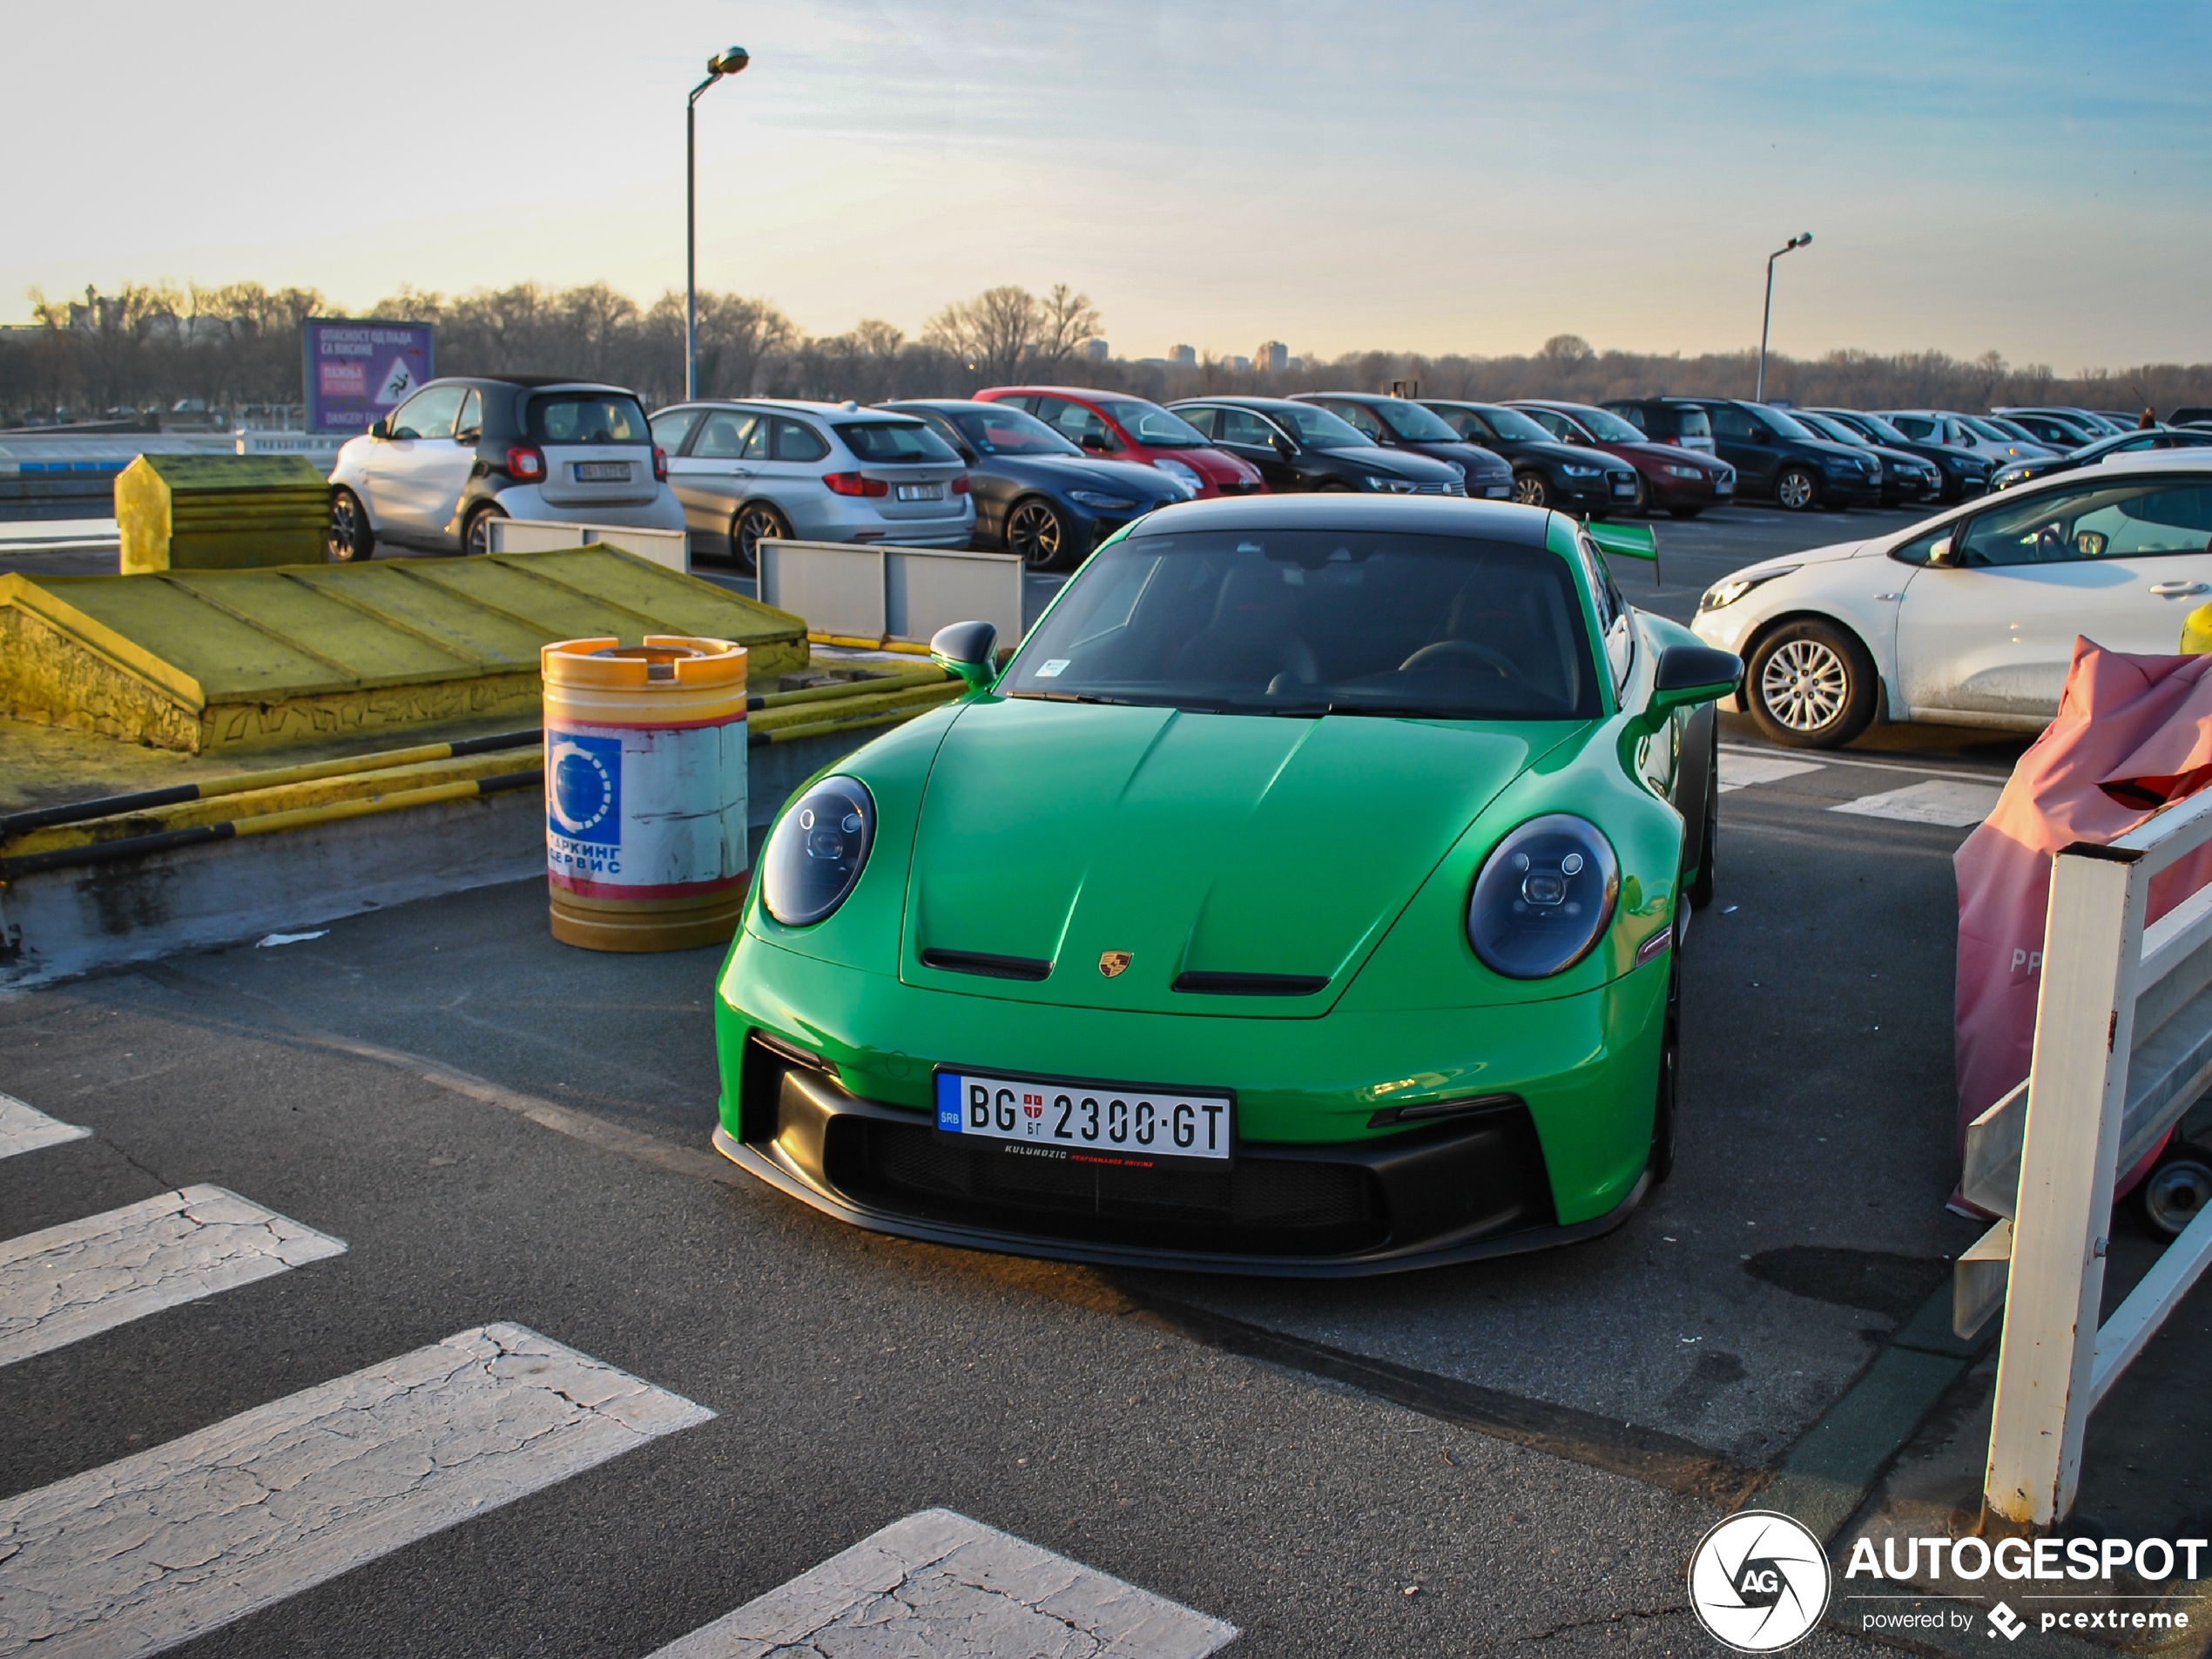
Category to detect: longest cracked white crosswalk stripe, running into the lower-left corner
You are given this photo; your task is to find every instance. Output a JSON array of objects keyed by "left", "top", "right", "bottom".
[{"left": 0, "top": 1325, "right": 714, "bottom": 1659}]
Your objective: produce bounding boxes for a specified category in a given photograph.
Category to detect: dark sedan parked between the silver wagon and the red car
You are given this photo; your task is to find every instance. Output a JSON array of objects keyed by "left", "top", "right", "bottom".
[{"left": 882, "top": 398, "right": 1190, "bottom": 570}]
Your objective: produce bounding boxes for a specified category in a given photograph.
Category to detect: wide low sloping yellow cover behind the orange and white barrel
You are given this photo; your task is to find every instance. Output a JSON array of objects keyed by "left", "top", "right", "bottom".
[{"left": 0, "top": 546, "right": 807, "bottom": 752}]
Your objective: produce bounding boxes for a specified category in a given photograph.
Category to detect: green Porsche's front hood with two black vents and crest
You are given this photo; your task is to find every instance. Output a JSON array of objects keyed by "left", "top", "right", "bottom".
[{"left": 900, "top": 699, "right": 1581, "bottom": 1017}]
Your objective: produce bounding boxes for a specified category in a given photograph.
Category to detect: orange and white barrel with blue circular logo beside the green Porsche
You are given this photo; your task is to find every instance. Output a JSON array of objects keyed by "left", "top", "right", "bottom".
[{"left": 540, "top": 632, "right": 752, "bottom": 951}]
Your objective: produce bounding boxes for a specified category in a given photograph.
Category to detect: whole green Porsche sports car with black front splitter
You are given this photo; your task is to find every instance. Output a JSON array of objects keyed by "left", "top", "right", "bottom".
[{"left": 714, "top": 496, "right": 1741, "bottom": 1274}]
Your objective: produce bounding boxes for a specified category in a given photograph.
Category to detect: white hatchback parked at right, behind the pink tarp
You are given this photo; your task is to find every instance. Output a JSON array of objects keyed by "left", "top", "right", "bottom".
[{"left": 1692, "top": 449, "right": 2212, "bottom": 748}]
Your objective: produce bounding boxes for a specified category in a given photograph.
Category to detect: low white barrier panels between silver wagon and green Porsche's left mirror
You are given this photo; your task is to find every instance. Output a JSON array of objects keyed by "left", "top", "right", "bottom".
[{"left": 761, "top": 540, "right": 1022, "bottom": 646}]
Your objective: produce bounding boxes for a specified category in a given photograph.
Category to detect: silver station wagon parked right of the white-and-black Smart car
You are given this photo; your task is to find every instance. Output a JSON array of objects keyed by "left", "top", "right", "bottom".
[{"left": 652, "top": 398, "right": 975, "bottom": 573}]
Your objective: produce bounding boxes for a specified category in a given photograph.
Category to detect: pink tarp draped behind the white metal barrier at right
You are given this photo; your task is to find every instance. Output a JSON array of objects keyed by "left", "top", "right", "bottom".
[{"left": 1951, "top": 639, "right": 2212, "bottom": 1185}]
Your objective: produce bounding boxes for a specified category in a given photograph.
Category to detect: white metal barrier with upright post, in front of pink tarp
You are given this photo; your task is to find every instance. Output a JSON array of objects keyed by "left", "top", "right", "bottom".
[{"left": 1953, "top": 790, "right": 2212, "bottom": 1528}]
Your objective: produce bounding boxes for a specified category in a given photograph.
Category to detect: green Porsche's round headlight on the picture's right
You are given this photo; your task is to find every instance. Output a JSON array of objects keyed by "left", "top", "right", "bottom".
[{"left": 1467, "top": 812, "right": 1622, "bottom": 980}]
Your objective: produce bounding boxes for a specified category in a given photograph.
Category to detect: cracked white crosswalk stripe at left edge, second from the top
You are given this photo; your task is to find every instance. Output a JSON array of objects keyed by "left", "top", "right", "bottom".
[{"left": 0, "top": 1185, "right": 345, "bottom": 1371}]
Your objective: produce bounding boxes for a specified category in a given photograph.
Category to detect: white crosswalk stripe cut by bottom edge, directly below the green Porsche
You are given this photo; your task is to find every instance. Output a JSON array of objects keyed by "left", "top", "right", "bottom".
[{"left": 651, "top": 1508, "right": 1237, "bottom": 1659}]
